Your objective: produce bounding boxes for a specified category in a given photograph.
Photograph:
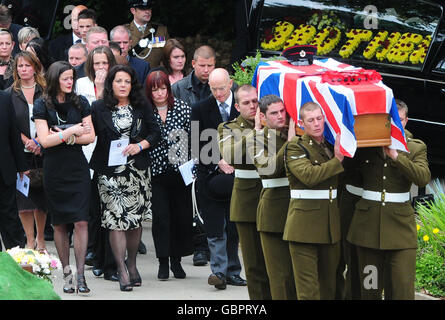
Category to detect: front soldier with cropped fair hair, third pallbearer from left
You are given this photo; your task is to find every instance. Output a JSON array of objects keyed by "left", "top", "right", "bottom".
[{"left": 283, "top": 102, "right": 344, "bottom": 300}]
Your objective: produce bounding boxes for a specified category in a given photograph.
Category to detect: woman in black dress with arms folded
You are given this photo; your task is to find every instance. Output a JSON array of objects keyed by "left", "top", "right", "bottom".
[{"left": 33, "top": 61, "right": 95, "bottom": 294}]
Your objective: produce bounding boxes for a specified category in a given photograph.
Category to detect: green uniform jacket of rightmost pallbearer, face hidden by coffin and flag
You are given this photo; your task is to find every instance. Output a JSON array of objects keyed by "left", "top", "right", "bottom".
[{"left": 347, "top": 131, "right": 431, "bottom": 249}]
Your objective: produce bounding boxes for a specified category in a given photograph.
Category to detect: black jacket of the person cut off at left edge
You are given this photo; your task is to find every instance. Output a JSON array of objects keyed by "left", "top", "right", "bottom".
[{"left": 0, "top": 91, "right": 28, "bottom": 185}]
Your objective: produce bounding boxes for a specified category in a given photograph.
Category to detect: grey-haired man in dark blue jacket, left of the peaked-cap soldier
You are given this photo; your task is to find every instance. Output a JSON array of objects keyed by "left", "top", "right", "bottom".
[{"left": 110, "top": 25, "right": 150, "bottom": 85}]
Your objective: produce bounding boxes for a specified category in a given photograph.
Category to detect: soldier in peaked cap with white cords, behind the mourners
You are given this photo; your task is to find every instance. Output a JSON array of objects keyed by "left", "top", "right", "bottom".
[{"left": 125, "top": 0, "right": 169, "bottom": 68}]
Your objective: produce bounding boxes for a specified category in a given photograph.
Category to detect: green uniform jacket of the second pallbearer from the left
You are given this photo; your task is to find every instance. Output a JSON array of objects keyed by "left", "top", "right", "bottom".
[{"left": 246, "top": 127, "right": 290, "bottom": 233}]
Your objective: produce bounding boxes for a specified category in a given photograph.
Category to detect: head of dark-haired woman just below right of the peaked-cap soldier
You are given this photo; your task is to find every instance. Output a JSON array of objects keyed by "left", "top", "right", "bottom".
[{"left": 162, "top": 39, "right": 187, "bottom": 85}]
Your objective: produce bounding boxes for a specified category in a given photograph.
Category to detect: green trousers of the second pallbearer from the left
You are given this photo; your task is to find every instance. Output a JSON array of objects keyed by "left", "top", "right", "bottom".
[{"left": 260, "top": 231, "right": 297, "bottom": 300}]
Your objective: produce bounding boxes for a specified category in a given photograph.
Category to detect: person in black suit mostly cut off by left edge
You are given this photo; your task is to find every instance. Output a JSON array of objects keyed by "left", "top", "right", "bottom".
[{"left": 0, "top": 91, "right": 28, "bottom": 251}]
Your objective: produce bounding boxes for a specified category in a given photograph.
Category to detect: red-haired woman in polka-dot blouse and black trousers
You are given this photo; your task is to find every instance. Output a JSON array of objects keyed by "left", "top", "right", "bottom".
[{"left": 145, "top": 70, "right": 193, "bottom": 280}]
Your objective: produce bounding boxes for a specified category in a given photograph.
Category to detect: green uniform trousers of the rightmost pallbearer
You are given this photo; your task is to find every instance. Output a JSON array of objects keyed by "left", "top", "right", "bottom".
[{"left": 357, "top": 246, "right": 416, "bottom": 300}]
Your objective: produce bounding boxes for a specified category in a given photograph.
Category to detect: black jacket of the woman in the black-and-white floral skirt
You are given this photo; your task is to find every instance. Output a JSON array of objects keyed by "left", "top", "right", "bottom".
[{"left": 90, "top": 100, "right": 161, "bottom": 176}]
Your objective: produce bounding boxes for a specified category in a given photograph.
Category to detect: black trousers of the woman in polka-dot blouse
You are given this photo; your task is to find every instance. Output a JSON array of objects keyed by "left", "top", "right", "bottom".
[{"left": 151, "top": 171, "right": 193, "bottom": 258}]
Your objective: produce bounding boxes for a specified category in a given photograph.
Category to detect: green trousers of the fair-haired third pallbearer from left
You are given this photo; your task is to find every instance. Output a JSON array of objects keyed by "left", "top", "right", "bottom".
[{"left": 289, "top": 241, "right": 340, "bottom": 300}]
